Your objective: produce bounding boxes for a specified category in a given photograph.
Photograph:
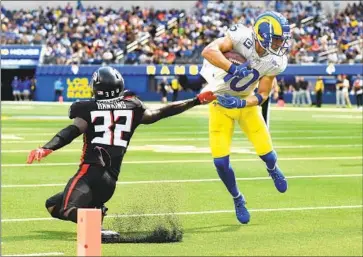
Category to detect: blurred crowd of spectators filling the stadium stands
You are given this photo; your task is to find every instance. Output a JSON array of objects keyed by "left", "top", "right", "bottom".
[{"left": 1, "top": 0, "right": 363, "bottom": 64}]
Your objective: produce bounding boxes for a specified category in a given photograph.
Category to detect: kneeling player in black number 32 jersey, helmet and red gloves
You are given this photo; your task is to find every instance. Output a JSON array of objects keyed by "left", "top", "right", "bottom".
[{"left": 27, "top": 66, "right": 215, "bottom": 238}]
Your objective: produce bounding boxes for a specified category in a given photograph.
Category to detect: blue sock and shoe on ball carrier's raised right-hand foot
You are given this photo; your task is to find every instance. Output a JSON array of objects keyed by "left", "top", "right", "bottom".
[{"left": 260, "top": 151, "right": 287, "bottom": 193}]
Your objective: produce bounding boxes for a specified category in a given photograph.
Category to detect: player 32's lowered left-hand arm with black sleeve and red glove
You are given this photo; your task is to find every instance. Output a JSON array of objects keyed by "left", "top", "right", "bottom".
[{"left": 27, "top": 117, "right": 88, "bottom": 164}]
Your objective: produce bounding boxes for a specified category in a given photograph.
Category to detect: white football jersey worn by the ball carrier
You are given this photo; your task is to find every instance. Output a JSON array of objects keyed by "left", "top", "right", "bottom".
[{"left": 200, "top": 24, "right": 287, "bottom": 98}]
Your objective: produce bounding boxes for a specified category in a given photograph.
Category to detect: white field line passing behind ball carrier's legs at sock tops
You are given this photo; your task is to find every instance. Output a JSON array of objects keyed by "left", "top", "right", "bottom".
[{"left": 1, "top": 156, "right": 363, "bottom": 167}]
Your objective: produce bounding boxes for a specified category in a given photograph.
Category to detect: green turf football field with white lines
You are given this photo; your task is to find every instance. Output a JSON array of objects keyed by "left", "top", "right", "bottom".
[{"left": 1, "top": 103, "right": 362, "bottom": 256}]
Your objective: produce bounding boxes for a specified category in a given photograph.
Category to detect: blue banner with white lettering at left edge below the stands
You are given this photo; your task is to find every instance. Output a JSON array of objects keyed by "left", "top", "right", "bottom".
[{"left": 1, "top": 45, "right": 42, "bottom": 60}]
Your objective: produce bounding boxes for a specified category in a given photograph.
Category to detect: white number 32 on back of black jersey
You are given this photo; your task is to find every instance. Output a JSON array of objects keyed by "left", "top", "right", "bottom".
[{"left": 91, "top": 110, "right": 133, "bottom": 147}]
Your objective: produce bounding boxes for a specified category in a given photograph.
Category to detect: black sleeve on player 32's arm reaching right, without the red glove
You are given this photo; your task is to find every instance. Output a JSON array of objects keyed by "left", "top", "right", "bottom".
[{"left": 141, "top": 98, "right": 200, "bottom": 124}]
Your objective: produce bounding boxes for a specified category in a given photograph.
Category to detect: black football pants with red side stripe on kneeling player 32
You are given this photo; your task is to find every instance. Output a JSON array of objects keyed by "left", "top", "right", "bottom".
[{"left": 45, "top": 164, "right": 116, "bottom": 223}]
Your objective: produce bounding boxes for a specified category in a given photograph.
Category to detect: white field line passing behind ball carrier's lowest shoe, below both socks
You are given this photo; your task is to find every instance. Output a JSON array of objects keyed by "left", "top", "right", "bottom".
[{"left": 1, "top": 205, "right": 363, "bottom": 223}]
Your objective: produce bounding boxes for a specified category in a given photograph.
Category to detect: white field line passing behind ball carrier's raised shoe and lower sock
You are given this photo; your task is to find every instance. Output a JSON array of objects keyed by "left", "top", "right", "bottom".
[{"left": 1, "top": 174, "right": 363, "bottom": 188}]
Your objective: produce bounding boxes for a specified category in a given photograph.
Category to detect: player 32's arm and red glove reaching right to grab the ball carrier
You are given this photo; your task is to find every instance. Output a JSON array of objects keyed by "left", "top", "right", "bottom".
[{"left": 141, "top": 91, "right": 216, "bottom": 124}]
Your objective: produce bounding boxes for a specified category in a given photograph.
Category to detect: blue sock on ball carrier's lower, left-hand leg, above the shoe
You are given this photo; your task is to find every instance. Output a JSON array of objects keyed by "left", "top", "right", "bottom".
[{"left": 214, "top": 155, "right": 240, "bottom": 197}]
